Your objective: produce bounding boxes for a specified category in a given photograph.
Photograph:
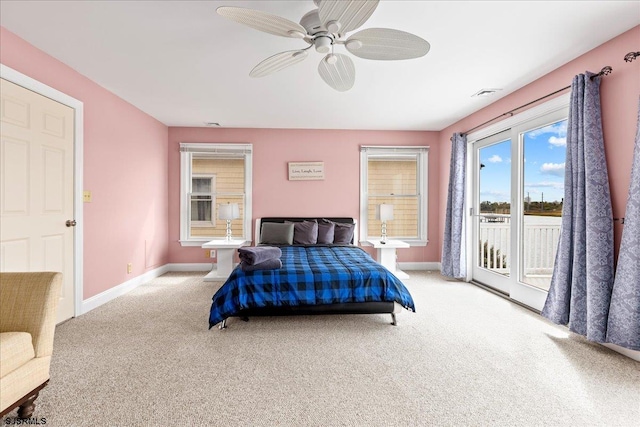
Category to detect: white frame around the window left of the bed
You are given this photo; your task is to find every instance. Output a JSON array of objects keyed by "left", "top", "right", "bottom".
[{"left": 179, "top": 142, "right": 253, "bottom": 246}]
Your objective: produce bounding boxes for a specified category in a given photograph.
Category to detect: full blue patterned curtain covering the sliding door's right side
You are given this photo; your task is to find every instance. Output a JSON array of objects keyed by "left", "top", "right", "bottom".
[{"left": 542, "top": 72, "right": 614, "bottom": 342}]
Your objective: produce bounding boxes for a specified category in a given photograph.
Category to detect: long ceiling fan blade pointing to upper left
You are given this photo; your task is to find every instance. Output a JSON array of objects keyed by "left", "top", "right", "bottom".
[{"left": 216, "top": 6, "right": 307, "bottom": 38}]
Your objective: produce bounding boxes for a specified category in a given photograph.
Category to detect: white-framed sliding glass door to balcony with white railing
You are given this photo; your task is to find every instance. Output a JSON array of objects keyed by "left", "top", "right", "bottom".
[{"left": 471, "top": 110, "right": 567, "bottom": 310}]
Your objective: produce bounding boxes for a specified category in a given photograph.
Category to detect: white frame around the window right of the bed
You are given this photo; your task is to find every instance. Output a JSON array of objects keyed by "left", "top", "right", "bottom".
[{"left": 360, "top": 145, "right": 429, "bottom": 246}]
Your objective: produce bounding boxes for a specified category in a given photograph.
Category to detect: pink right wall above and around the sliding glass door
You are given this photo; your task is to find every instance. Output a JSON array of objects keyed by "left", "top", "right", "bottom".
[{"left": 439, "top": 26, "right": 640, "bottom": 262}]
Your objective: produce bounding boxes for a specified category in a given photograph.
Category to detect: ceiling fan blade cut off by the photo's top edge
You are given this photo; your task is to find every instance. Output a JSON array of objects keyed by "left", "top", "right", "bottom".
[{"left": 318, "top": 0, "right": 380, "bottom": 34}]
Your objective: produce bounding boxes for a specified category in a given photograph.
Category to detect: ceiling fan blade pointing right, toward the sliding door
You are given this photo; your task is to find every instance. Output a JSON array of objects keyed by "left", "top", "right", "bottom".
[{"left": 345, "top": 28, "right": 431, "bottom": 60}]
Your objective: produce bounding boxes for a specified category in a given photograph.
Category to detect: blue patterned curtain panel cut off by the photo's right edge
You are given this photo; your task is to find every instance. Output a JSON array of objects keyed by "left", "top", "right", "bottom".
[{"left": 607, "top": 98, "right": 640, "bottom": 350}]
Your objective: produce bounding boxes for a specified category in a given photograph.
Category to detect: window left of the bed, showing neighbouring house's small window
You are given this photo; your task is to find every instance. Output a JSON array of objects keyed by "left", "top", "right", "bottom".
[{"left": 180, "top": 143, "right": 252, "bottom": 246}]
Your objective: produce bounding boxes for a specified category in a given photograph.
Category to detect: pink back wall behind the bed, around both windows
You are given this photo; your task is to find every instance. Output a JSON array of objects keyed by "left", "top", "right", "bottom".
[{"left": 169, "top": 128, "right": 440, "bottom": 262}]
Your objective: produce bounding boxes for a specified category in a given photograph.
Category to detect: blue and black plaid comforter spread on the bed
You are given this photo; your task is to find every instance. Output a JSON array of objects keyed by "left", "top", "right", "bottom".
[{"left": 209, "top": 246, "right": 415, "bottom": 328}]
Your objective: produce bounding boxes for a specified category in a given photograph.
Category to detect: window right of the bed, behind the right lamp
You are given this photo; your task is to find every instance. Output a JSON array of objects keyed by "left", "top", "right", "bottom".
[{"left": 360, "top": 146, "right": 428, "bottom": 246}]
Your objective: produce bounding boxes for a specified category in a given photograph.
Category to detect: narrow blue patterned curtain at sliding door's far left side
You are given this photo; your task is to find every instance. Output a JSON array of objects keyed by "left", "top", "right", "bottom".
[{"left": 442, "top": 133, "right": 467, "bottom": 278}]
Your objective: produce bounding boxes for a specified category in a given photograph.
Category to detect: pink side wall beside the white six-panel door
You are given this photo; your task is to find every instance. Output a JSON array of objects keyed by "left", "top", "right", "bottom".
[{"left": 0, "top": 28, "right": 168, "bottom": 299}]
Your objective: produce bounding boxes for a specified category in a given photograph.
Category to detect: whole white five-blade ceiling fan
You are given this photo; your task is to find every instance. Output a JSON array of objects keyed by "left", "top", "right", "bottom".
[{"left": 216, "top": 0, "right": 430, "bottom": 92}]
